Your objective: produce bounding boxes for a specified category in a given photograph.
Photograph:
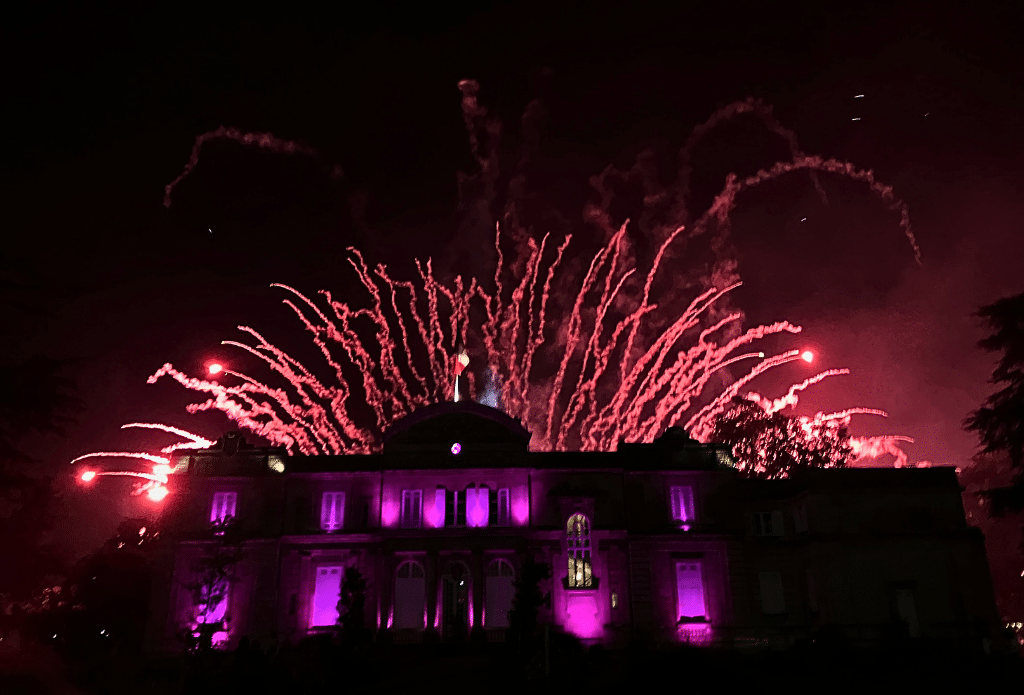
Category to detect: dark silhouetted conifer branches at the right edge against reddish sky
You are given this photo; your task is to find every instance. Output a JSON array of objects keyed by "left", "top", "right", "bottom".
[{"left": 965, "top": 293, "right": 1024, "bottom": 516}]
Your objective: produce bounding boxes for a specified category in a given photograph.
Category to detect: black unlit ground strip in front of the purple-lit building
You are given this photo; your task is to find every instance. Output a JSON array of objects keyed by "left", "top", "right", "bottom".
[{"left": 0, "top": 639, "right": 1024, "bottom": 695}]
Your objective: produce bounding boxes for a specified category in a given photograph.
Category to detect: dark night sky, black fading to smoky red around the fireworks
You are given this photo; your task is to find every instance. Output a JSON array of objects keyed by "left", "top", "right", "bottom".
[{"left": 0, "top": 2, "right": 1024, "bottom": 560}]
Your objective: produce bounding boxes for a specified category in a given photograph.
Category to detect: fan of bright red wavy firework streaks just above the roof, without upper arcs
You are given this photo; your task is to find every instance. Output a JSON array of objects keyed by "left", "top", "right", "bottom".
[{"left": 136, "top": 227, "right": 905, "bottom": 454}]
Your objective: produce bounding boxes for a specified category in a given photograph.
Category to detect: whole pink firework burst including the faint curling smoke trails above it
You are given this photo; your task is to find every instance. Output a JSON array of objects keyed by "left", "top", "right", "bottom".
[{"left": 74, "top": 81, "right": 921, "bottom": 463}]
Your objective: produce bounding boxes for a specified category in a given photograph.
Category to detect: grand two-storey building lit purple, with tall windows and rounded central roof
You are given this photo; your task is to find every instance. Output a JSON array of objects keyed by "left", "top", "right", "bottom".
[{"left": 140, "top": 401, "right": 999, "bottom": 652}]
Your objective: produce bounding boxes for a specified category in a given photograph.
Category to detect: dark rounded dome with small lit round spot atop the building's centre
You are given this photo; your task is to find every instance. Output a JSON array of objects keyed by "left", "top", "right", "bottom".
[{"left": 384, "top": 400, "right": 530, "bottom": 453}]
